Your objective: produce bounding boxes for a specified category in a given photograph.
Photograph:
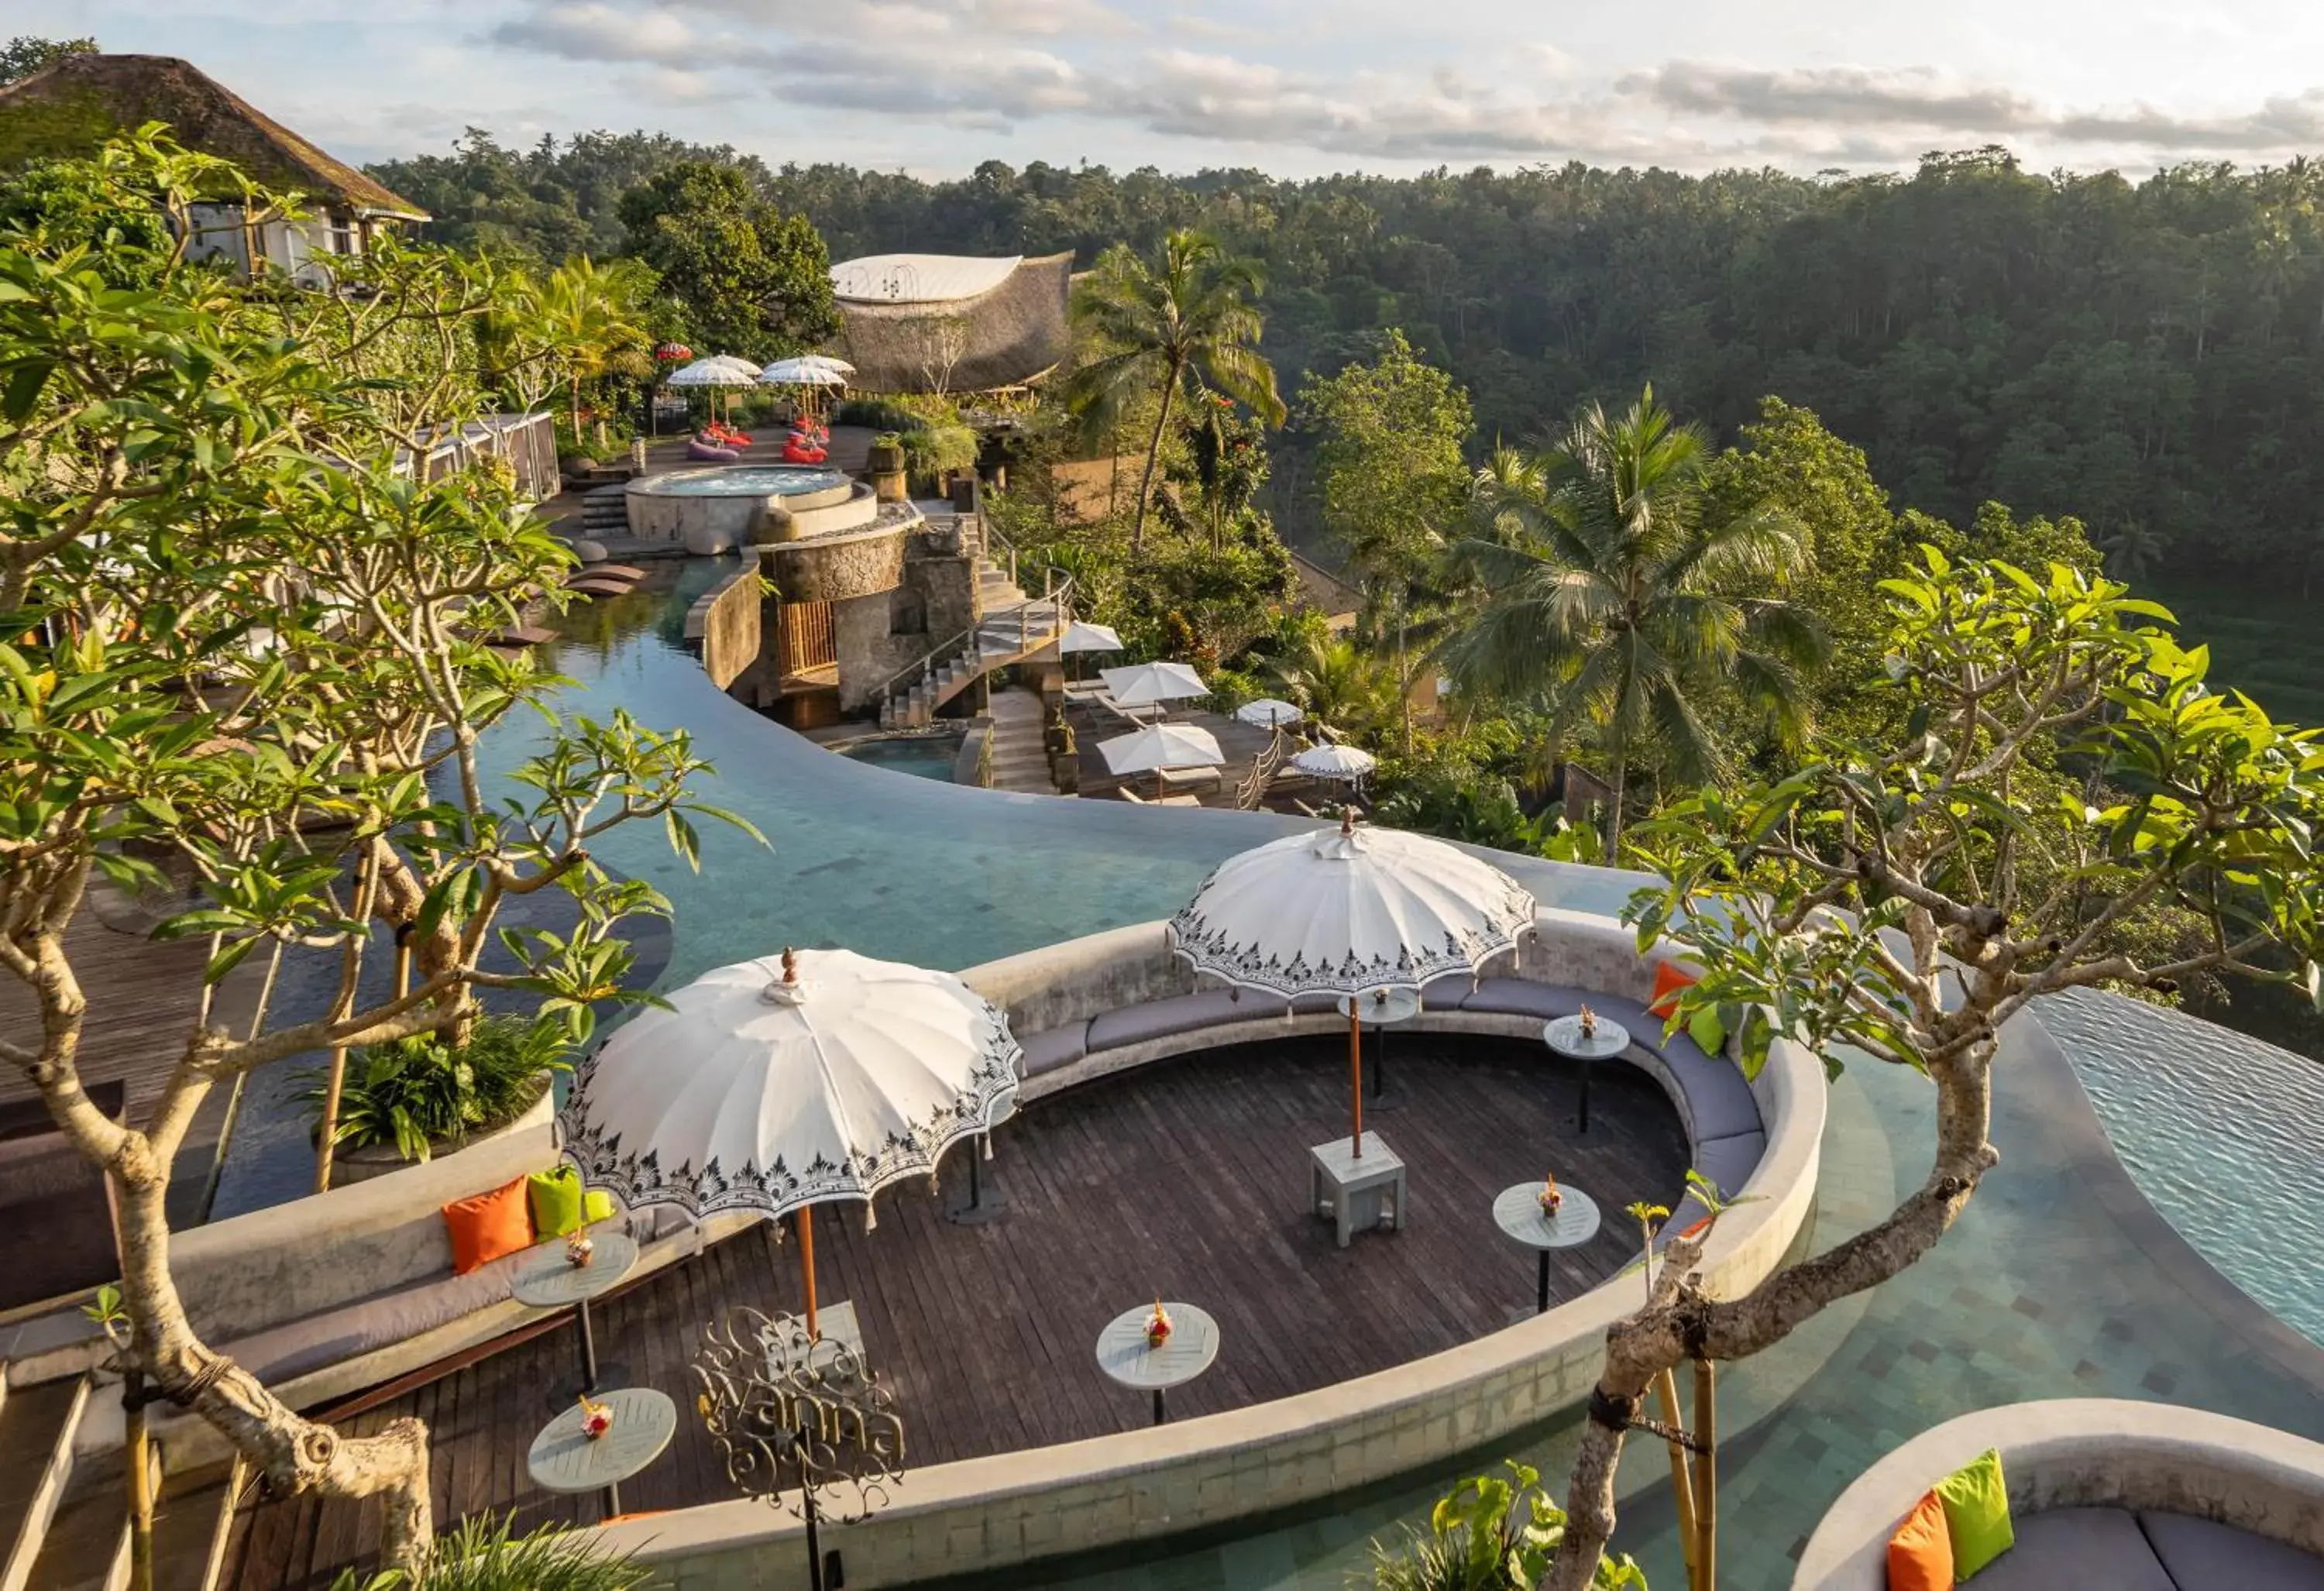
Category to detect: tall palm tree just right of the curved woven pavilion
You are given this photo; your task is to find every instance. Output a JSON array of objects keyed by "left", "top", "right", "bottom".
[{"left": 1067, "top": 228, "right": 1285, "bottom": 553}]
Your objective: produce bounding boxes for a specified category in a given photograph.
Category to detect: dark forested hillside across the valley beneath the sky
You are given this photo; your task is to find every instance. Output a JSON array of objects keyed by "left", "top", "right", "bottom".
[{"left": 374, "top": 135, "right": 2324, "bottom": 576}]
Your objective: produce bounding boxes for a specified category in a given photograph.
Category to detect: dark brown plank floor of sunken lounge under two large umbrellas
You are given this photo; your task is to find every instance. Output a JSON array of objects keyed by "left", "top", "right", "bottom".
[{"left": 230, "top": 1033, "right": 1687, "bottom": 1591}]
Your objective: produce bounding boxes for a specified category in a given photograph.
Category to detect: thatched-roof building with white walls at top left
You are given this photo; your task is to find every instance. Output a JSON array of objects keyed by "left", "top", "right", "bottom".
[{"left": 0, "top": 53, "right": 428, "bottom": 286}]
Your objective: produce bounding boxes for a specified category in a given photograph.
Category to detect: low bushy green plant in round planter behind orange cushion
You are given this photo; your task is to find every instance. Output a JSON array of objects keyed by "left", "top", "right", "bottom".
[{"left": 297, "top": 1015, "right": 572, "bottom": 1159}]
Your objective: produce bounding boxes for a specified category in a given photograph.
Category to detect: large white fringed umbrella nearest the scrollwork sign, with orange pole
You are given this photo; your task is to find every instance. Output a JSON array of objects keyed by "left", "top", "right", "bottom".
[{"left": 558, "top": 950, "right": 1023, "bottom": 1335}]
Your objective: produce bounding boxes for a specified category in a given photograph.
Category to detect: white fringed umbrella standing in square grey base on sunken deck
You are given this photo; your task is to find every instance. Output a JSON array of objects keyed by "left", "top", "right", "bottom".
[{"left": 1169, "top": 817, "right": 1536, "bottom": 1154}]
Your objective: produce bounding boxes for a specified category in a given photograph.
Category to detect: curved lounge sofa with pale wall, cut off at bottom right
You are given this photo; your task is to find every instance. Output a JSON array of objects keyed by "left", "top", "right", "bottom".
[{"left": 1792, "top": 1398, "right": 2324, "bottom": 1591}]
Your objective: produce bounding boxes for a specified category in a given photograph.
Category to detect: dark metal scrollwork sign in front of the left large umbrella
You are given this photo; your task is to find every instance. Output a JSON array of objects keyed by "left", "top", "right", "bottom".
[{"left": 693, "top": 1305, "right": 904, "bottom": 1524}]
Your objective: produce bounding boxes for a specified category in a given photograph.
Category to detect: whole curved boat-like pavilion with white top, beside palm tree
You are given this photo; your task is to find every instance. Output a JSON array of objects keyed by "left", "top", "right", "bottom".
[{"left": 832, "top": 253, "right": 1074, "bottom": 393}]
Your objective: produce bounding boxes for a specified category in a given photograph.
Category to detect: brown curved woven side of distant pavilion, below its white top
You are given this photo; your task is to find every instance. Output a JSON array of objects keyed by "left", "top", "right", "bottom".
[{"left": 832, "top": 253, "right": 1074, "bottom": 393}]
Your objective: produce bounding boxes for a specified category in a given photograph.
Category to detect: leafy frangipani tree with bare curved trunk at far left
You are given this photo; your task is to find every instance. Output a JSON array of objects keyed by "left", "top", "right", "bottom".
[{"left": 0, "top": 135, "right": 748, "bottom": 1568}]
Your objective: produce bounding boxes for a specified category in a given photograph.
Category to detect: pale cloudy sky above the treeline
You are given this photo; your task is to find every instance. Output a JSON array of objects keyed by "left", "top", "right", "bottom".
[{"left": 18, "top": 0, "right": 2324, "bottom": 177}]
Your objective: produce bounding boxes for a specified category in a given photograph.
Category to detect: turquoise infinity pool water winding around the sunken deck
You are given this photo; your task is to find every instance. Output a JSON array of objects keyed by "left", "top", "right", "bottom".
[{"left": 472, "top": 560, "right": 2324, "bottom": 1591}]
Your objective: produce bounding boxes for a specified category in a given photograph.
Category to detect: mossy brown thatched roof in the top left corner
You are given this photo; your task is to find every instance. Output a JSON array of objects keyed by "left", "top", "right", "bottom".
[{"left": 0, "top": 56, "right": 428, "bottom": 221}]
